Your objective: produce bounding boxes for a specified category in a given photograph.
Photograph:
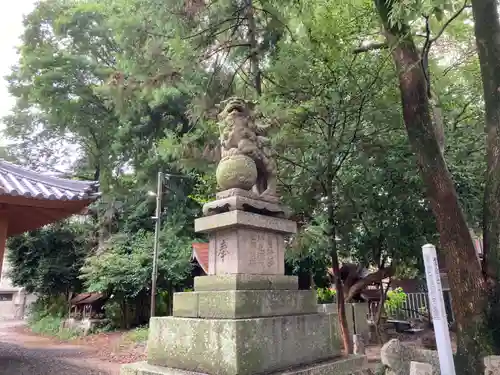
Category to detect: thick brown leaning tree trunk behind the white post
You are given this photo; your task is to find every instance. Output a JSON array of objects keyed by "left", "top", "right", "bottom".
[{"left": 375, "top": 0, "right": 485, "bottom": 375}]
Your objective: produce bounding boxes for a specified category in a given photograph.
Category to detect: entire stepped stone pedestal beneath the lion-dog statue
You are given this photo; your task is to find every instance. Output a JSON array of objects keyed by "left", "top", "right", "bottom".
[{"left": 122, "top": 206, "right": 367, "bottom": 375}]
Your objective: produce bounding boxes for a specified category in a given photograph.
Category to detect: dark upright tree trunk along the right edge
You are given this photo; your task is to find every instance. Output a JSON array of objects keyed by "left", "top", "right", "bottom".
[{"left": 472, "top": 0, "right": 500, "bottom": 352}]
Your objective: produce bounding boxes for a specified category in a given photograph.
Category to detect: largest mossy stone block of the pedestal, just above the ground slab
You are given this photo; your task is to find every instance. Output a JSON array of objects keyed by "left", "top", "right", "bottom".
[{"left": 148, "top": 314, "right": 341, "bottom": 375}]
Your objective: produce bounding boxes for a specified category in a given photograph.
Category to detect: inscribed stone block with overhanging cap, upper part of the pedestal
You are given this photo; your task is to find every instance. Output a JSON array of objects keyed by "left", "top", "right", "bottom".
[{"left": 195, "top": 210, "right": 297, "bottom": 275}]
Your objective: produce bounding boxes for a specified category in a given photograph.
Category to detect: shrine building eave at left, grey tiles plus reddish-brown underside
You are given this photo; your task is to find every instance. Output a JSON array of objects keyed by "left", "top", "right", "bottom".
[{"left": 0, "top": 159, "right": 100, "bottom": 237}]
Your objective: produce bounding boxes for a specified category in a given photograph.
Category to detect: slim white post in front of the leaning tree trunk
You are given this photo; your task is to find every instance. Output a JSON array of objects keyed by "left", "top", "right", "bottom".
[{"left": 422, "top": 244, "right": 455, "bottom": 375}]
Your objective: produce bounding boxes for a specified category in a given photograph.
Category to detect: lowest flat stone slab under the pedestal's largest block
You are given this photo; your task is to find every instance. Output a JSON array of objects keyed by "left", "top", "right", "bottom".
[{"left": 120, "top": 356, "right": 371, "bottom": 375}]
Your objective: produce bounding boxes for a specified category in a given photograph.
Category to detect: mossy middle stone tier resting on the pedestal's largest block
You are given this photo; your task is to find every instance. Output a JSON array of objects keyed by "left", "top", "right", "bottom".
[{"left": 173, "top": 290, "right": 317, "bottom": 319}]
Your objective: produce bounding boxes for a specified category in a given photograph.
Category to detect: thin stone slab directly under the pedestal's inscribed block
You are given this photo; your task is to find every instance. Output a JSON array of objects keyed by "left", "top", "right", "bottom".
[{"left": 194, "top": 274, "right": 299, "bottom": 292}]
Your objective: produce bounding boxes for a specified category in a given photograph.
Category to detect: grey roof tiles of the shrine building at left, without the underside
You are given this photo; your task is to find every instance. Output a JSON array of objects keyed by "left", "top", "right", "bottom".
[{"left": 0, "top": 159, "right": 99, "bottom": 201}]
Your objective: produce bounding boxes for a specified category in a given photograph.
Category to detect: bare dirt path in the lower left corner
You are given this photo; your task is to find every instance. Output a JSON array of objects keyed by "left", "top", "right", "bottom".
[{"left": 0, "top": 322, "right": 121, "bottom": 375}]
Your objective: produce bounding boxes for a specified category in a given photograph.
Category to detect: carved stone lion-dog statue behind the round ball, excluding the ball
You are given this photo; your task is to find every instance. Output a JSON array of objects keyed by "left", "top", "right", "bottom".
[{"left": 219, "top": 98, "right": 277, "bottom": 197}]
